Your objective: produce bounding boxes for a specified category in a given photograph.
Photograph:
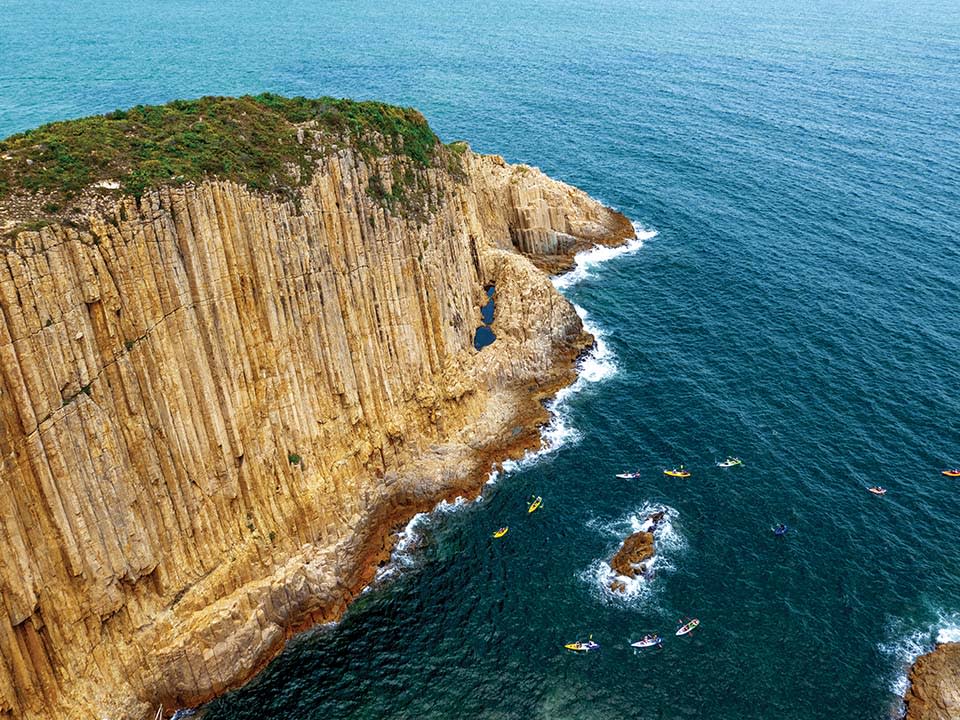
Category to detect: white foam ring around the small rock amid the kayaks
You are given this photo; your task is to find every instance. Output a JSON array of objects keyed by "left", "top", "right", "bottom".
[{"left": 579, "top": 503, "right": 687, "bottom": 605}]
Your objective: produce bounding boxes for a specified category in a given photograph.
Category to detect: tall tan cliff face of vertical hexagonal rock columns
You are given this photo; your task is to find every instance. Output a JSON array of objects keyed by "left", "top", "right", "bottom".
[{"left": 0, "top": 131, "right": 632, "bottom": 720}]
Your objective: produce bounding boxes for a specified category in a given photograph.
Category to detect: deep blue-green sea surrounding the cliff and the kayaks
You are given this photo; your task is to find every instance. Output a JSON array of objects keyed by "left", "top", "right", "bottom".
[{"left": 0, "top": 0, "right": 960, "bottom": 720}]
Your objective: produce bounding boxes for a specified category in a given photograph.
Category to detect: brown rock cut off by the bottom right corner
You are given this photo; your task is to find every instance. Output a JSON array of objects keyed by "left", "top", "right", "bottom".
[{"left": 905, "top": 643, "right": 960, "bottom": 720}]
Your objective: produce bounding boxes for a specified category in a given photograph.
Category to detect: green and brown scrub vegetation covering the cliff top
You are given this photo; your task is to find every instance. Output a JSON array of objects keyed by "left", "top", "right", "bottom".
[{"left": 0, "top": 94, "right": 459, "bottom": 215}]
